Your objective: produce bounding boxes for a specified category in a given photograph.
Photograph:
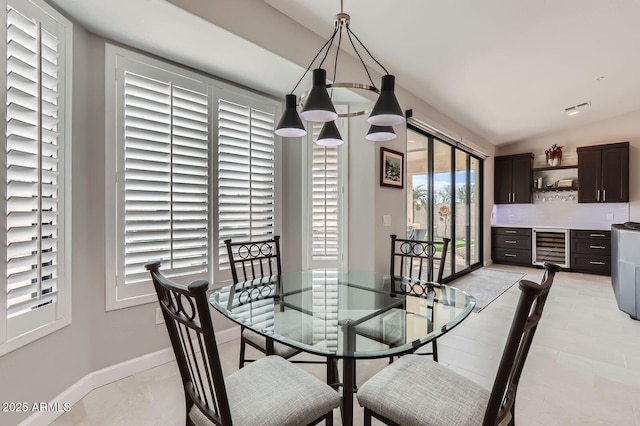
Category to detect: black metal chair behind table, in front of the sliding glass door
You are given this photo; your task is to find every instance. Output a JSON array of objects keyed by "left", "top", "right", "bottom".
[{"left": 389, "top": 234, "right": 451, "bottom": 361}]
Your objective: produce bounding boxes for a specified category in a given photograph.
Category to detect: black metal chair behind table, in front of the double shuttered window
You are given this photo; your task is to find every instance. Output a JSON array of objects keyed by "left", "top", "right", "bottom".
[{"left": 224, "top": 235, "right": 337, "bottom": 383}]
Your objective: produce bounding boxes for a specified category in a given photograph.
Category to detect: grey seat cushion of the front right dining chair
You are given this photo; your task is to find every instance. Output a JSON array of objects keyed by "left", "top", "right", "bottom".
[{"left": 357, "top": 355, "right": 490, "bottom": 426}]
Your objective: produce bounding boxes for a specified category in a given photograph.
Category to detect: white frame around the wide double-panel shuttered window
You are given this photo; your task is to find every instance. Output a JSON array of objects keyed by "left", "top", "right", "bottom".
[{"left": 105, "top": 43, "right": 282, "bottom": 311}]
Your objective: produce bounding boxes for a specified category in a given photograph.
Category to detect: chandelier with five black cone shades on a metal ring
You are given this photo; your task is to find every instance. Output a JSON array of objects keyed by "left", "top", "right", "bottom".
[{"left": 275, "top": 0, "right": 405, "bottom": 145}]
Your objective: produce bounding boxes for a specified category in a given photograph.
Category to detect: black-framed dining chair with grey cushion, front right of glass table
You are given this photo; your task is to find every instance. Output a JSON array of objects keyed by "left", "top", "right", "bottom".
[{"left": 357, "top": 263, "right": 560, "bottom": 426}]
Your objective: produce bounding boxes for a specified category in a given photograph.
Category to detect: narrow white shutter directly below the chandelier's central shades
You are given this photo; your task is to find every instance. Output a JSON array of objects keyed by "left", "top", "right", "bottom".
[{"left": 311, "top": 123, "right": 342, "bottom": 260}]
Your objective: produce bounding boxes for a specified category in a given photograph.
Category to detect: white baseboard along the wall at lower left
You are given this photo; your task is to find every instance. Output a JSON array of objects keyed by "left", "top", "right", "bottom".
[{"left": 20, "top": 327, "right": 240, "bottom": 426}]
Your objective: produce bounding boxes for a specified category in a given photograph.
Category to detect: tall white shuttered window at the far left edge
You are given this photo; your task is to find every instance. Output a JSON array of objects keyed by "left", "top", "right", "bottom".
[{"left": 0, "top": 2, "right": 66, "bottom": 340}]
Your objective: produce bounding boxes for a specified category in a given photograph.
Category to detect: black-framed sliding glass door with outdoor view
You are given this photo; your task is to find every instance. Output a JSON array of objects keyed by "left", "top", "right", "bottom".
[{"left": 407, "top": 127, "right": 483, "bottom": 281}]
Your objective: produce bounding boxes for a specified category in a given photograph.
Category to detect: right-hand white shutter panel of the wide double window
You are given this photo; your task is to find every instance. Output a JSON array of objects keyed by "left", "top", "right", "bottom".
[{"left": 218, "top": 96, "right": 275, "bottom": 269}]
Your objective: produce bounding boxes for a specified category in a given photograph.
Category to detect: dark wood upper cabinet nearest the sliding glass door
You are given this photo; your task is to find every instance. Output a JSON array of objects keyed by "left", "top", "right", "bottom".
[{"left": 493, "top": 153, "right": 533, "bottom": 204}]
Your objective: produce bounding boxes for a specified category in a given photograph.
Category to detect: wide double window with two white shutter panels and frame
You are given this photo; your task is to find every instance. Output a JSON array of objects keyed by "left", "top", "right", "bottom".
[{"left": 105, "top": 44, "right": 280, "bottom": 310}]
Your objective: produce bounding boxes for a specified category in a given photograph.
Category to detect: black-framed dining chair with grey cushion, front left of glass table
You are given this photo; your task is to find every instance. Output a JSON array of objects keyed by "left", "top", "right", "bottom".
[{"left": 145, "top": 262, "right": 340, "bottom": 426}]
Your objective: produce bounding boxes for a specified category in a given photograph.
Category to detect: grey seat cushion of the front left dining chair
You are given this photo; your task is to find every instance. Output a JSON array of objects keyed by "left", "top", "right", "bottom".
[{"left": 189, "top": 355, "right": 340, "bottom": 426}]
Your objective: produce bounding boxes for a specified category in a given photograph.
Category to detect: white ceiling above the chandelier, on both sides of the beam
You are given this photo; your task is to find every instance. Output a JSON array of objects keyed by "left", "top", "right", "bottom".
[{"left": 51, "top": 0, "right": 640, "bottom": 144}]
